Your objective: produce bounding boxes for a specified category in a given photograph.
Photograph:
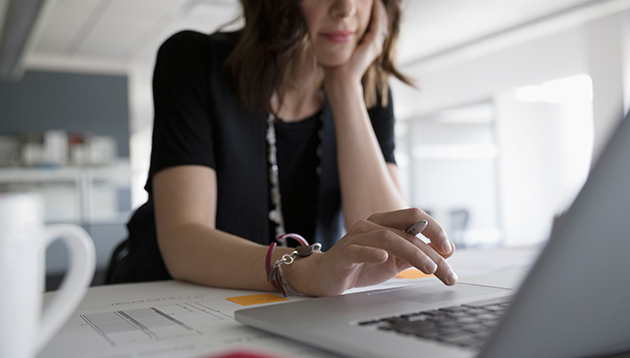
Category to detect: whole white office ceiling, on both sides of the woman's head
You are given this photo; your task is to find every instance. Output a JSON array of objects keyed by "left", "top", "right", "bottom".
[{"left": 0, "top": 0, "right": 628, "bottom": 77}]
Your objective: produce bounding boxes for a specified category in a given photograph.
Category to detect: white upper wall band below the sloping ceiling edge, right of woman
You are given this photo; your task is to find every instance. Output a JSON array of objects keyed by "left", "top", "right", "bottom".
[{"left": 392, "top": 10, "right": 630, "bottom": 153}]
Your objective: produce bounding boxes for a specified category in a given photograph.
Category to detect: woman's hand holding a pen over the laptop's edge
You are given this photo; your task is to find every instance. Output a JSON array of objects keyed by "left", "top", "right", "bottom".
[{"left": 285, "top": 209, "right": 457, "bottom": 296}]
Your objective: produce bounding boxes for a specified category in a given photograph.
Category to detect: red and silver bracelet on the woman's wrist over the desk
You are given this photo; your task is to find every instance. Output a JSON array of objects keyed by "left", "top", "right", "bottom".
[{"left": 265, "top": 234, "right": 322, "bottom": 297}]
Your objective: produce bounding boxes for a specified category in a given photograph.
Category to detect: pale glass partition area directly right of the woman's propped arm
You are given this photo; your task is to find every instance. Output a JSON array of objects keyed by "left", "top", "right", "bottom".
[{"left": 397, "top": 109, "right": 501, "bottom": 247}]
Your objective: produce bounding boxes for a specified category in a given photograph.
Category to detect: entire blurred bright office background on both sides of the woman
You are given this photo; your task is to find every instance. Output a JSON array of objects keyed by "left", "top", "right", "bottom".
[{"left": 0, "top": 0, "right": 630, "bottom": 284}]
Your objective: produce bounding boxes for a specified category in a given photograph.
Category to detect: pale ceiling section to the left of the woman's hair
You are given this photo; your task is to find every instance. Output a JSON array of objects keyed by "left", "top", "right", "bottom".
[{"left": 25, "top": 0, "right": 239, "bottom": 72}]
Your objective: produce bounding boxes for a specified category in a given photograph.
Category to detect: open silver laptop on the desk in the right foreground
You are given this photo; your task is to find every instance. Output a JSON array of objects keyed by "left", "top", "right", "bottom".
[{"left": 235, "top": 110, "right": 630, "bottom": 358}]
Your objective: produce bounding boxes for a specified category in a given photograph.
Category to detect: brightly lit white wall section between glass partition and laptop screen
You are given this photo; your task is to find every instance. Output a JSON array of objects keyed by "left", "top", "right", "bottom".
[{"left": 495, "top": 95, "right": 593, "bottom": 246}]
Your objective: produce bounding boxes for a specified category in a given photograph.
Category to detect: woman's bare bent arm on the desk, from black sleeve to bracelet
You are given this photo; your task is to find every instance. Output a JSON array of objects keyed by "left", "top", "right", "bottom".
[{"left": 153, "top": 165, "right": 302, "bottom": 291}]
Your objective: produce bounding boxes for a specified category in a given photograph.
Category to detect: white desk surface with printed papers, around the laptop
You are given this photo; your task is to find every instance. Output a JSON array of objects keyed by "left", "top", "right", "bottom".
[{"left": 39, "top": 249, "right": 535, "bottom": 358}]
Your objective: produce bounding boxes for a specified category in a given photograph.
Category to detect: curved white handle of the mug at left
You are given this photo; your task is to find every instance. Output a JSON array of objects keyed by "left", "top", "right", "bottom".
[{"left": 35, "top": 224, "right": 96, "bottom": 352}]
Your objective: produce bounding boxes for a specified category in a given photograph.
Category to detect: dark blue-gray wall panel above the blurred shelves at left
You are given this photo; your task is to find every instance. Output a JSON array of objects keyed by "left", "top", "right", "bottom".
[{"left": 0, "top": 71, "right": 129, "bottom": 157}]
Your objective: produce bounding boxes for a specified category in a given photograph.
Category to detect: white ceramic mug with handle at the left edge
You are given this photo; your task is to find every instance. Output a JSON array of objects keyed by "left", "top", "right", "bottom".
[{"left": 0, "top": 193, "right": 96, "bottom": 358}]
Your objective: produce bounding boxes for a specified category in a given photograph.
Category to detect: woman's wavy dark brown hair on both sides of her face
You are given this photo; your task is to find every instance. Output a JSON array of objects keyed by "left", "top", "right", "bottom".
[{"left": 227, "top": 0, "right": 412, "bottom": 112}]
